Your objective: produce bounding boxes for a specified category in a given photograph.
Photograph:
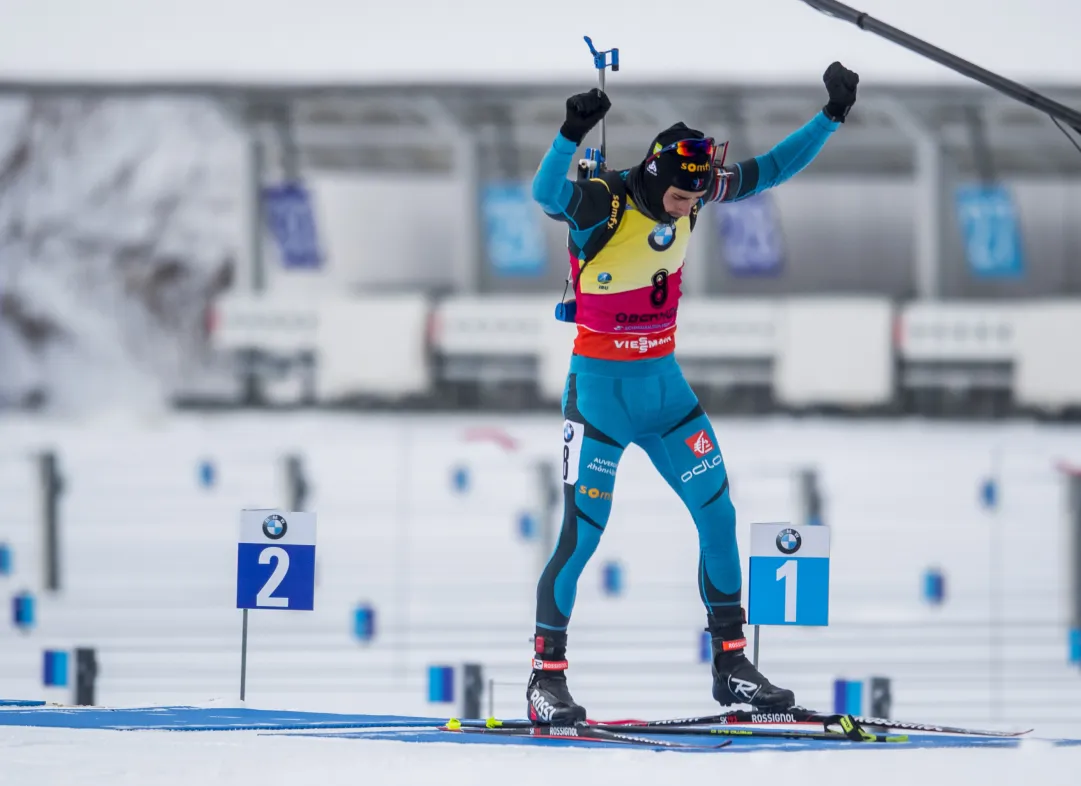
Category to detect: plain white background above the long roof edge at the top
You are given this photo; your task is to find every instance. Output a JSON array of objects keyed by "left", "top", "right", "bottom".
[{"left": 0, "top": 0, "right": 1081, "bottom": 84}]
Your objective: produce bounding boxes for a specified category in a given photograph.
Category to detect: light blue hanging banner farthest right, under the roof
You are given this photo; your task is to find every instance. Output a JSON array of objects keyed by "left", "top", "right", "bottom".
[{"left": 957, "top": 185, "right": 1025, "bottom": 278}]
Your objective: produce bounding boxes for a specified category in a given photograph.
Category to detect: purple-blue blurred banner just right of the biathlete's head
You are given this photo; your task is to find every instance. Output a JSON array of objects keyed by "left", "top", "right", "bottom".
[{"left": 718, "top": 194, "right": 785, "bottom": 276}]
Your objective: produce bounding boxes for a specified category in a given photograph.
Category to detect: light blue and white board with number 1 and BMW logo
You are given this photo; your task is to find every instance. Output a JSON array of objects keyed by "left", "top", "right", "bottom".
[{"left": 747, "top": 523, "right": 829, "bottom": 625}]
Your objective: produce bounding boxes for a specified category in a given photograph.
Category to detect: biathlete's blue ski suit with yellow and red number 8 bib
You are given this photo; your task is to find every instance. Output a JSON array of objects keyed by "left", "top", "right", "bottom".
[{"left": 533, "top": 112, "right": 840, "bottom": 632}]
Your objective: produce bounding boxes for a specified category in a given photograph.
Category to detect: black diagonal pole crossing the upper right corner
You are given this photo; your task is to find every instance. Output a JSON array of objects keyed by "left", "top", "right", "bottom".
[{"left": 803, "top": 0, "right": 1081, "bottom": 134}]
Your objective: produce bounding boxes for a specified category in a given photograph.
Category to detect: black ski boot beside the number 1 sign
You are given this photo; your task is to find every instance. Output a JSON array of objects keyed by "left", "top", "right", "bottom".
[{"left": 706, "top": 609, "right": 796, "bottom": 710}]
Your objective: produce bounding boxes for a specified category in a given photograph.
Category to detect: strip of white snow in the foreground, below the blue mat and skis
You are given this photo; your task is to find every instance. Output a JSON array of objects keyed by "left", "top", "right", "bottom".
[{"left": 0, "top": 728, "right": 1081, "bottom": 786}]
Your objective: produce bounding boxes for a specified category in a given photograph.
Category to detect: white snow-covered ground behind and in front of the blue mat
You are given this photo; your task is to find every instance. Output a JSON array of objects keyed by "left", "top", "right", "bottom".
[{"left": 0, "top": 414, "right": 1081, "bottom": 786}]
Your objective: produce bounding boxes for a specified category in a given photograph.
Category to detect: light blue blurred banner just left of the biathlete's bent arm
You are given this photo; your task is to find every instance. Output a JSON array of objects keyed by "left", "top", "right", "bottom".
[{"left": 481, "top": 183, "right": 548, "bottom": 277}]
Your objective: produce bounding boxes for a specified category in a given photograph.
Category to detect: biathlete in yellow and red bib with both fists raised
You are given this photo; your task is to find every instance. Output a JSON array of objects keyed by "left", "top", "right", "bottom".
[{"left": 526, "top": 63, "right": 859, "bottom": 723}]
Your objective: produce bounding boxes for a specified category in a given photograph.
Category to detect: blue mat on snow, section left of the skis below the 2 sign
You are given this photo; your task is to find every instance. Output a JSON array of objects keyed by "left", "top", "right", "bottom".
[{"left": 0, "top": 706, "right": 446, "bottom": 731}]
